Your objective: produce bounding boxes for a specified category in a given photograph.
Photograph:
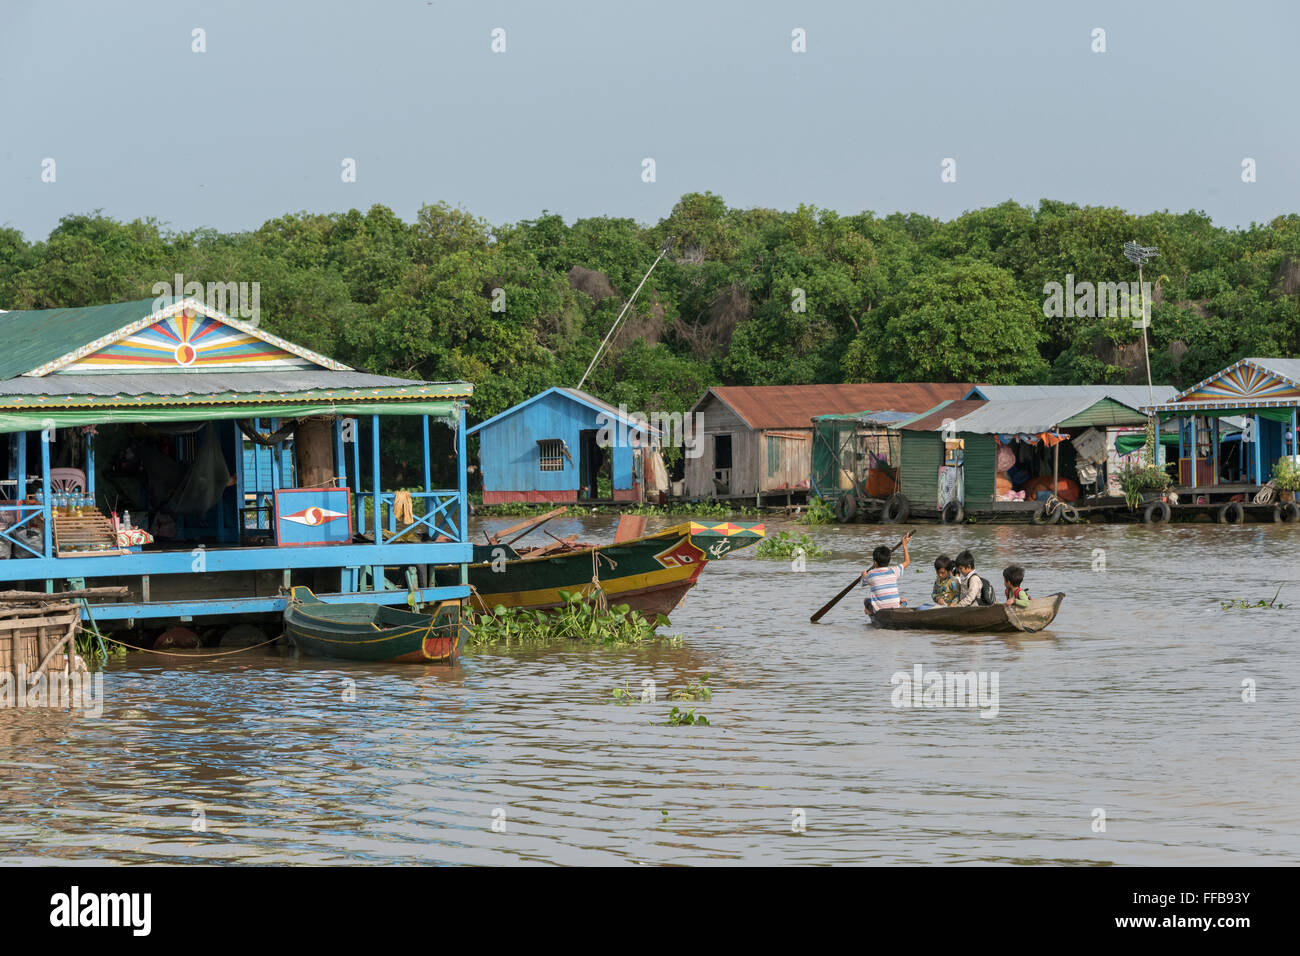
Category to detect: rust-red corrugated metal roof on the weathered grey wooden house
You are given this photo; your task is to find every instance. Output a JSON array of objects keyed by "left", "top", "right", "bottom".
[{"left": 692, "top": 382, "right": 971, "bottom": 429}]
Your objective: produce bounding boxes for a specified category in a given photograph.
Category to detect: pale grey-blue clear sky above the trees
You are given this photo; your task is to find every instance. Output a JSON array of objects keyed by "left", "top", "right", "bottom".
[{"left": 0, "top": 0, "right": 1300, "bottom": 241}]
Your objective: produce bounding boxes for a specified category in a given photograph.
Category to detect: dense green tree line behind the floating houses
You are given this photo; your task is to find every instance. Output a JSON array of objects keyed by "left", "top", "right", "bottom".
[{"left": 0, "top": 193, "right": 1300, "bottom": 419}]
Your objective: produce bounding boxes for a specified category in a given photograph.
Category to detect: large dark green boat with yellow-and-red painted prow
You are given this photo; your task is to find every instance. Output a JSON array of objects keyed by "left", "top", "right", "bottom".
[{"left": 436, "top": 522, "right": 764, "bottom": 614}]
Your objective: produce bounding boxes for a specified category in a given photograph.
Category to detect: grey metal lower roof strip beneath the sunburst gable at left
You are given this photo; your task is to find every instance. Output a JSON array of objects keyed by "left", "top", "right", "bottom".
[{"left": 0, "top": 368, "right": 429, "bottom": 395}]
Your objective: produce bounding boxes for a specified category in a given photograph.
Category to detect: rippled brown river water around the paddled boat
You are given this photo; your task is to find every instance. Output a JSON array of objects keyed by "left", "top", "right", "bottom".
[{"left": 0, "top": 518, "right": 1300, "bottom": 865}]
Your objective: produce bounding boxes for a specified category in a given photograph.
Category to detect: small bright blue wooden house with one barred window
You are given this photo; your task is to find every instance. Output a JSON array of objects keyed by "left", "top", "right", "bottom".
[{"left": 469, "top": 386, "right": 654, "bottom": 505}]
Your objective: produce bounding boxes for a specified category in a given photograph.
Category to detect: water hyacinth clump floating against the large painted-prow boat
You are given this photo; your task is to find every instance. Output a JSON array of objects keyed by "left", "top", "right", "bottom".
[{"left": 465, "top": 589, "right": 668, "bottom": 646}]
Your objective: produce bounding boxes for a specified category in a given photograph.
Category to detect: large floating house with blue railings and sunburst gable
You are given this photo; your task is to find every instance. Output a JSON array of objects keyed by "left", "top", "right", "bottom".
[{"left": 0, "top": 299, "right": 473, "bottom": 626}]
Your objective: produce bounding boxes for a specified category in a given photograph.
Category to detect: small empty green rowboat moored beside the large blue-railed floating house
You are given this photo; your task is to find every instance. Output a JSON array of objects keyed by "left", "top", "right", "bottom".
[{"left": 285, "top": 588, "right": 462, "bottom": 663}]
